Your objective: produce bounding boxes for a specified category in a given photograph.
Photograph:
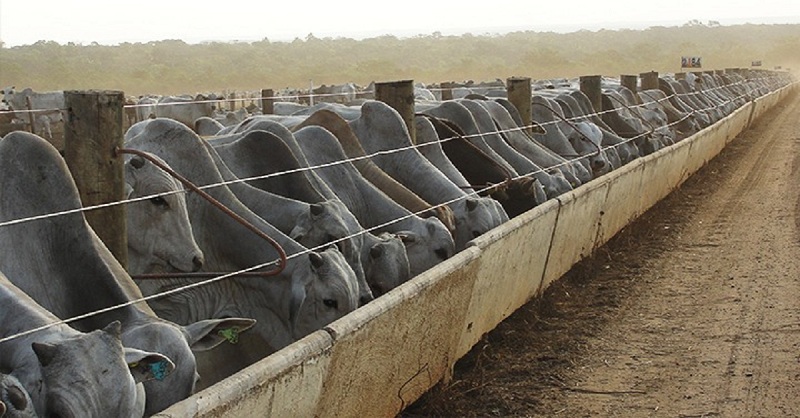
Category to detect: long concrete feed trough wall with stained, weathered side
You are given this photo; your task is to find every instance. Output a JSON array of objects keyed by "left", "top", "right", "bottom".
[{"left": 157, "top": 83, "right": 789, "bottom": 417}]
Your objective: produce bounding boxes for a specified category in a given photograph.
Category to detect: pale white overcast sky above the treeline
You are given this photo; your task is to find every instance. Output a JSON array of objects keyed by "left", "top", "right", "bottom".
[{"left": 0, "top": 0, "right": 800, "bottom": 46}]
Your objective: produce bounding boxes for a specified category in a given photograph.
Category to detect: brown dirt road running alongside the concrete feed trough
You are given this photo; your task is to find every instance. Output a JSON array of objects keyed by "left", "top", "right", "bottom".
[{"left": 402, "top": 89, "right": 800, "bottom": 418}]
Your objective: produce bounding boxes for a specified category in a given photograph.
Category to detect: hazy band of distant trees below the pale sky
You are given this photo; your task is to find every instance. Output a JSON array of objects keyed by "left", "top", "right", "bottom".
[{"left": 0, "top": 20, "right": 800, "bottom": 95}]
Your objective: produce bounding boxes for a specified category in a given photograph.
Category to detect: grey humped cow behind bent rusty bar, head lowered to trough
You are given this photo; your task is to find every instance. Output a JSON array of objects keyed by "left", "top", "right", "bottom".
[{"left": 126, "top": 118, "right": 358, "bottom": 385}]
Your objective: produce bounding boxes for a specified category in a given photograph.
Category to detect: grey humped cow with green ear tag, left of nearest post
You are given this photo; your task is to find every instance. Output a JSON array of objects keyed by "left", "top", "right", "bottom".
[{"left": 0, "top": 132, "right": 253, "bottom": 414}]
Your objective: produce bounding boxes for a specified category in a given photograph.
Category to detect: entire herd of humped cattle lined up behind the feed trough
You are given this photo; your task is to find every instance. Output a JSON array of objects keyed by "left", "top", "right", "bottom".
[{"left": 0, "top": 72, "right": 792, "bottom": 417}]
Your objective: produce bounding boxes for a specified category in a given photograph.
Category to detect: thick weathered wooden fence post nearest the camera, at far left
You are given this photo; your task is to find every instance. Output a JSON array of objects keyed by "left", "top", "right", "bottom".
[{"left": 64, "top": 90, "right": 128, "bottom": 269}]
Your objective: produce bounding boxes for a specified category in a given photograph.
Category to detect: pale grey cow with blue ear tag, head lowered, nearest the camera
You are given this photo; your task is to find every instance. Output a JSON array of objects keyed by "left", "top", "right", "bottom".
[{"left": 0, "top": 273, "right": 175, "bottom": 418}]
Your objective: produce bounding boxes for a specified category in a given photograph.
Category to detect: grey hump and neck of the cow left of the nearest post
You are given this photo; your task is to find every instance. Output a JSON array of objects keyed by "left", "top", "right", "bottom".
[{"left": 0, "top": 133, "right": 152, "bottom": 330}]
